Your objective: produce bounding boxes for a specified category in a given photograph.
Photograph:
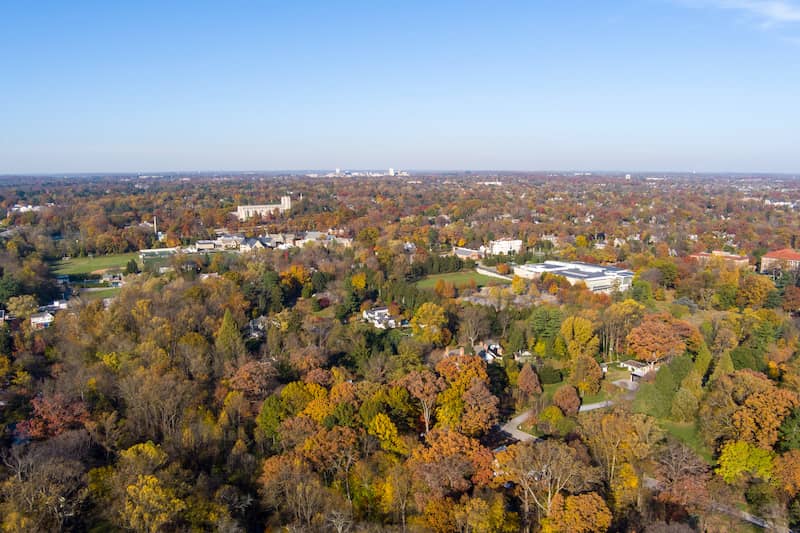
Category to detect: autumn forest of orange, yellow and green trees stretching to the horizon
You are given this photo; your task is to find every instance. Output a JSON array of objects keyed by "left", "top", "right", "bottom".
[{"left": 0, "top": 174, "right": 800, "bottom": 533}]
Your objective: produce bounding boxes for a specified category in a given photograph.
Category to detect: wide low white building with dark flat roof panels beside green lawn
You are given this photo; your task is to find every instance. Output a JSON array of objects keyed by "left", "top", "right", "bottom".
[{"left": 514, "top": 261, "right": 633, "bottom": 293}]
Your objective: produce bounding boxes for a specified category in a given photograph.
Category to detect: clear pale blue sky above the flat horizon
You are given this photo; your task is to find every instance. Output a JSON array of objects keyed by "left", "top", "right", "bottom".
[{"left": 0, "top": 0, "right": 800, "bottom": 173}]
